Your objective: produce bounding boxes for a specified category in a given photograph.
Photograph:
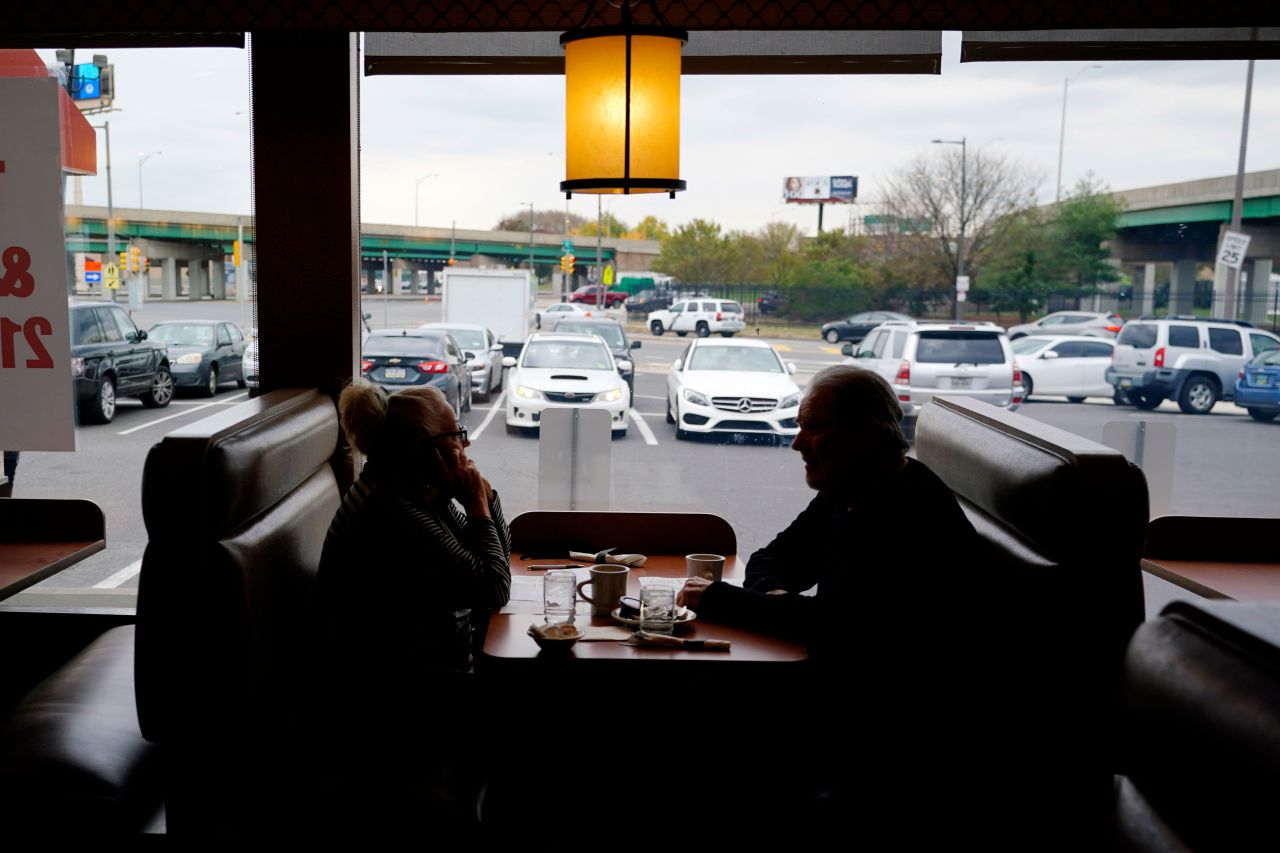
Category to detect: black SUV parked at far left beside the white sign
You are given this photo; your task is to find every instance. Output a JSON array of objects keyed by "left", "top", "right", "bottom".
[{"left": 69, "top": 302, "right": 173, "bottom": 424}]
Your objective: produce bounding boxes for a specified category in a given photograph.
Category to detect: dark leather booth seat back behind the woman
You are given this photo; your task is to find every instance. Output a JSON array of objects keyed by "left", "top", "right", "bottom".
[{"left": 136, "top": 391, "right": 339, "bottom": 838}]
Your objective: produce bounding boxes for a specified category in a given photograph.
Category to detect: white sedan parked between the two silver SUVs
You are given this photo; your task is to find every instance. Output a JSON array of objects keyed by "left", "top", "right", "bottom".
[{"left": 1010, "top": 334, "right": 1115, "bottom": 402}]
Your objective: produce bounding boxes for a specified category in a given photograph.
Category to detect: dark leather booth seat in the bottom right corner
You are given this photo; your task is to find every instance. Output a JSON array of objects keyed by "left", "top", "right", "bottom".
[{"left": 1115, "top": 599, "right": 1280, "bottom": 853}]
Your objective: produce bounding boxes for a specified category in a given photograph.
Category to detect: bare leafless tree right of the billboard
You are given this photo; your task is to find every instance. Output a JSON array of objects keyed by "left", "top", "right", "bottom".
[{"left": 883, "top": 146, "right": 1043, "bottom": 288}]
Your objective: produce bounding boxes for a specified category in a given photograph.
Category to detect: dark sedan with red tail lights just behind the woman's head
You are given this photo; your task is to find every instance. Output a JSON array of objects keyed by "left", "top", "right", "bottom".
[{"left": 360, "top": 329, "right": 471, "bottom": 418}]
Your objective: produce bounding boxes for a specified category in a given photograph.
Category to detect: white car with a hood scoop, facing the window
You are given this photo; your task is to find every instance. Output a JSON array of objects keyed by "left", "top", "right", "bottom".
[{"left": 503, "top": 333, "right": 631, "bottom": 438}]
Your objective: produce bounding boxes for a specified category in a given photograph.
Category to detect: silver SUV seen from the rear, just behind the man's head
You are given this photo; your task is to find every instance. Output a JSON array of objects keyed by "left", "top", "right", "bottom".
[{"left": 844, "top": 321, "right": 1024, "bottom": 433}]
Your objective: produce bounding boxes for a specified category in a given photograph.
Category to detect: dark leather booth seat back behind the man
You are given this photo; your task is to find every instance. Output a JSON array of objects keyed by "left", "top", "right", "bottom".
[{"left": 905, "top": 397, "right": 1148, "bottom": 847}]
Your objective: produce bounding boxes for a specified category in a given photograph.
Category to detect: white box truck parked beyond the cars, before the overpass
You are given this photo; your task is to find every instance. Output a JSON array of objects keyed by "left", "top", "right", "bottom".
[{"left": 442, "top": 269, "right": 534, "bottom": 355}]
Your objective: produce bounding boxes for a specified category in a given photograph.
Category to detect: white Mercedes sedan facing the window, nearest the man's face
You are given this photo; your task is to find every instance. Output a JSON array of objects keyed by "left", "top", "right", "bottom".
[{"left": 667, "top": 338, "right": 801, "bottom": 438}]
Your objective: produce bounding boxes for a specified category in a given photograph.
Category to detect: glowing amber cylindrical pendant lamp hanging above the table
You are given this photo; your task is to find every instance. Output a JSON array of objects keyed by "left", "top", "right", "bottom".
[{"left": 561, "top": 0, "right": 689, "bottom": 199}]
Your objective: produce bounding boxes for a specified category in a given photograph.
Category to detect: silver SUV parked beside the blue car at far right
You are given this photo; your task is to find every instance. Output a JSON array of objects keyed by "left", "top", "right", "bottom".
[{"left": 1106, "top": 316, "right": 1280, "bottom": 415}]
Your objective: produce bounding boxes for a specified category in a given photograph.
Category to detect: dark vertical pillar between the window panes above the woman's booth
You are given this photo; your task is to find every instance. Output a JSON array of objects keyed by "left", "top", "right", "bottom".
[{"left": 250, "top": 32, "right": 360, "bottom": 396}]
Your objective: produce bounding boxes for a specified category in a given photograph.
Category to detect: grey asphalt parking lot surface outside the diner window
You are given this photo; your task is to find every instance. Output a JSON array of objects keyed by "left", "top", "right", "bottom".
[{"left": 13, "top": 297, "right": 1280, "bottom": 605}]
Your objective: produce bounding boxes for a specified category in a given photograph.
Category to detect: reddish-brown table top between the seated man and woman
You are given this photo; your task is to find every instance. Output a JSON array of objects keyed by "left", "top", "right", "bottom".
[{"left": 480, "top": 555, "right": 809, "bottom": 669}]
